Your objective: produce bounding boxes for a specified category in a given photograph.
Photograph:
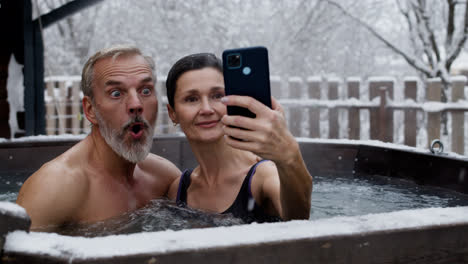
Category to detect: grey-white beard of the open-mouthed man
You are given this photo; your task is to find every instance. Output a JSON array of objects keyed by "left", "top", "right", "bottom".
[{"left": 95, "top": 108, "right": 154, "bottom": 163}]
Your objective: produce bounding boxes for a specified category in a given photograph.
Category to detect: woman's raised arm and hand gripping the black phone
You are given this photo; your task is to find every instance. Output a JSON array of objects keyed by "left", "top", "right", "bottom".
[{"left": 222, "top": 96, "right": 312, "bottom": 220}]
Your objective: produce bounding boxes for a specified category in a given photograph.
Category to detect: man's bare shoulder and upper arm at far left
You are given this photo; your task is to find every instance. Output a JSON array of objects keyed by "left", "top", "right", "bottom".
[{"left": 16, "top": 163, "right": 88, "bottom": 231}]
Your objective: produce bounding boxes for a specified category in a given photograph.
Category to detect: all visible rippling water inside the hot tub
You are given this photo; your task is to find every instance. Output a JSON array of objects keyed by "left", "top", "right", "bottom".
[{"left": 0, "top": 174, "right": 468, "bottom": 236}]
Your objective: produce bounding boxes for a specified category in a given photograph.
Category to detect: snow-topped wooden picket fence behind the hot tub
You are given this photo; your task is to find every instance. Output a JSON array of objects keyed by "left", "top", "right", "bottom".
[{"left": 45, "top": 76, "right": 468, "bottom": 154}]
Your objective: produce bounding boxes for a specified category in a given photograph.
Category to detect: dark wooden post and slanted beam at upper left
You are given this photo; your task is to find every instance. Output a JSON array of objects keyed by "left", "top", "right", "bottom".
[{"left": 0, "top": 0, "right": 102, "bottom": 138}]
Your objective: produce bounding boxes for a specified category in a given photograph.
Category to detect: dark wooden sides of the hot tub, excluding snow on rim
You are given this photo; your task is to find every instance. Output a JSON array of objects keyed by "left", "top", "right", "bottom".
[{"left": 0, "top": 137, "right": 468, "bottom": 263}]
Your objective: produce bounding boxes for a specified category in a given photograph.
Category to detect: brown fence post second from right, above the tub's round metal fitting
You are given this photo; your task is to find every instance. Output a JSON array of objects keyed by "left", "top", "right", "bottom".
[{"left": 426, "top": 78, "right": 442, "bottom": 146}]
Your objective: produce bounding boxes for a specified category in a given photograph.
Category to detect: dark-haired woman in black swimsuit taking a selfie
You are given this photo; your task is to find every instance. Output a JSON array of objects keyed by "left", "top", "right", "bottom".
[{"left": 166, "top": 53, "right": 312, "bottom": 223}]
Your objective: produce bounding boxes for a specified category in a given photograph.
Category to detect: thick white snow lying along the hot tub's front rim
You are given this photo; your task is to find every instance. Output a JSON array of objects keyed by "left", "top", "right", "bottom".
[{"left": 4, "top": 207, "right": 468, "bottom": 259}]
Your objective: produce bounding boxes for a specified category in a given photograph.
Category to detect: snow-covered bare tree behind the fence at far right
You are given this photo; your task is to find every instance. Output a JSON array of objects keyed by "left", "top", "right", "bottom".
[{"left": 321, "top": 0, "right": 468, "bottom": 98}]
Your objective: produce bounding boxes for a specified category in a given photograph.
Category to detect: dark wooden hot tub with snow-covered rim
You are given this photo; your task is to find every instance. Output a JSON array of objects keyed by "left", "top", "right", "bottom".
[{"left": 0, "top": 137, "right": 468, "bottom": 263}]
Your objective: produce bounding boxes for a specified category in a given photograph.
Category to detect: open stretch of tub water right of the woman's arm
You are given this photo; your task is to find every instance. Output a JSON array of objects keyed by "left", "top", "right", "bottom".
[{"left": 310, "top": 176, "right": 468, "bottom": 220}]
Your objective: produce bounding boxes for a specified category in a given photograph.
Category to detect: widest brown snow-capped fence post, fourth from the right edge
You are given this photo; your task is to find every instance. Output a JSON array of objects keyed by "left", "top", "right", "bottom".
[{"left": 369, "top": 78, "right": 394, "bottom": 142}]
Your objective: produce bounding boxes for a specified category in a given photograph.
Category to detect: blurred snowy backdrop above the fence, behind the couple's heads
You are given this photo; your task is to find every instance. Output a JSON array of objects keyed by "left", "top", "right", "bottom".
[{"left": 33, "top": 0, "right": 414, "bottom": 78}]
